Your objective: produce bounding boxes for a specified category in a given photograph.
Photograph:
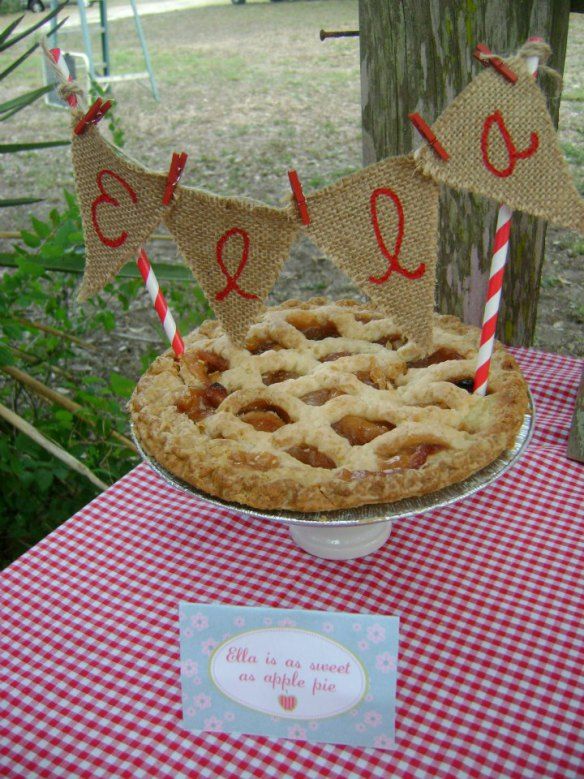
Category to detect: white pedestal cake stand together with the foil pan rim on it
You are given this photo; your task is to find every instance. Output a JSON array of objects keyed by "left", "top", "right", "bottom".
[{"left": 132, "top": 395, "right": 535, "bottom": 560}]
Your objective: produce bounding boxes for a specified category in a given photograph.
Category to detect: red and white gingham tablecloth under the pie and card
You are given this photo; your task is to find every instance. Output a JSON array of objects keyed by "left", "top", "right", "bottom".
[{"left": 0, "top": 349, "right": 584, "bottom": 779}]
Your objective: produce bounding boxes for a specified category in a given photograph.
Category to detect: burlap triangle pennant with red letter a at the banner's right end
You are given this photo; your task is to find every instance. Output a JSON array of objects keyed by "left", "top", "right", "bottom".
[{"left": 417, "top": 57, "right": 584, "bottom": 232}]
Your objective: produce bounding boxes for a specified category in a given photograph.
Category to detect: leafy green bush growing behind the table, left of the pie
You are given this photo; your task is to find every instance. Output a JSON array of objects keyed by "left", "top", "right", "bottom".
[{"left": 0, "top": 192, "right": 209, "bottom": 566}]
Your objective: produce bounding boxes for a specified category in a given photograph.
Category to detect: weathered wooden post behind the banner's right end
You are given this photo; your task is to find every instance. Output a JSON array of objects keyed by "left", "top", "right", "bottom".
[{"left": 359, "top": 0, "right": 570, "bottom": 345}]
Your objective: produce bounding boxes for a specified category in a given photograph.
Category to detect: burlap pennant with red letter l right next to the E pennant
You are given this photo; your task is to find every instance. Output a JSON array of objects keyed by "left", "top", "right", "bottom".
[{"left": 165, "top": 187, "right": 298, "bottom": 343}]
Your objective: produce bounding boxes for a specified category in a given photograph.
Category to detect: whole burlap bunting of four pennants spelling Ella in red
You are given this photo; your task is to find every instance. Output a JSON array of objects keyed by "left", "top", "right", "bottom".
[{"left": 67, "top": 41, "right": 584, "bottom": 351}]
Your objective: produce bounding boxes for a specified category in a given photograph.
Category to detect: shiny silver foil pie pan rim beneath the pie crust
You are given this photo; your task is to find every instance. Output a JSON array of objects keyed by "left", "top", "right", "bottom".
[{"left": 130, "top": 393, "right": 535, "bottom": 527}]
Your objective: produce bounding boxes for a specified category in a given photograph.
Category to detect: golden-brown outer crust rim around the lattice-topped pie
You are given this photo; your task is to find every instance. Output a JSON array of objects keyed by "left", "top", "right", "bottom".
[{"left": 129, "top": 298, "right": 528, "bottom": 512}]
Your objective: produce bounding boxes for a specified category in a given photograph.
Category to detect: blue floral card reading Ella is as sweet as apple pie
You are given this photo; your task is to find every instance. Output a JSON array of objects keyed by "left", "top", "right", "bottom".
[{"left": 180, "top": 603, "right": 399, "bottom": 749}]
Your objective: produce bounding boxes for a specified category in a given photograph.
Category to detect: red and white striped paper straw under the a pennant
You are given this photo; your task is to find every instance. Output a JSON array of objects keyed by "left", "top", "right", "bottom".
[{"left": 473, "top": 45, "right": 541, "bottom": 395}]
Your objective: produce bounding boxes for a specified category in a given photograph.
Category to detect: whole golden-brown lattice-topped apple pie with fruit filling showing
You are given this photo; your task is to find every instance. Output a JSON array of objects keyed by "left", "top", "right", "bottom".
[{"left": 130, "top": 298, "right": 528, "bottom": 512}]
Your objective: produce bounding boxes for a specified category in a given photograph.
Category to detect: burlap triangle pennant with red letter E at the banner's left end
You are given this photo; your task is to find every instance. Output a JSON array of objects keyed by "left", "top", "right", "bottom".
[{"left": 71, "top": 126, "right": 166, "bottom": 300}]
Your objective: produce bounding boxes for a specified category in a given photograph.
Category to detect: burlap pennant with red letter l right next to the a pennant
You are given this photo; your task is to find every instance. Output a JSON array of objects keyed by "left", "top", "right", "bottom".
[{"left": 306, "top": 156, "right": 438, "bottom": 350}]
